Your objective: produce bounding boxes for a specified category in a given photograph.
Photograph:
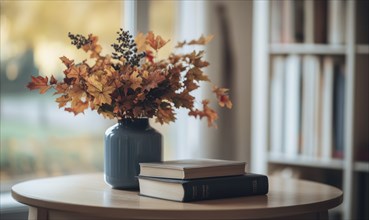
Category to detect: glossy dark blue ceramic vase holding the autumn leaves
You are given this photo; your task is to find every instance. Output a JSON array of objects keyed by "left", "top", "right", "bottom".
[{"left": 104, "top": 118, "right": 162, "bottom": 189}]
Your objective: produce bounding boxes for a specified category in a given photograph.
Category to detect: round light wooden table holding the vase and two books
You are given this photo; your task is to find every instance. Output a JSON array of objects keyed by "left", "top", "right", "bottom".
[{"left": 12, "top": 173, "right": 343, "bottom": 220}]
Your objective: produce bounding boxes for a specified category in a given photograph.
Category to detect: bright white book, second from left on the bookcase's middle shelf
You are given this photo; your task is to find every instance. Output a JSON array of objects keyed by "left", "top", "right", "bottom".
[{"left": 283, "top": 55, "right": 301, "bottom": 157}]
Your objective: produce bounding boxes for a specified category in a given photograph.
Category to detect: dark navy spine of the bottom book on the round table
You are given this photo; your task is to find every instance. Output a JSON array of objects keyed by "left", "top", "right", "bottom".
[{"left": 183, "top": 176, "right": 269, "bottom": 202}]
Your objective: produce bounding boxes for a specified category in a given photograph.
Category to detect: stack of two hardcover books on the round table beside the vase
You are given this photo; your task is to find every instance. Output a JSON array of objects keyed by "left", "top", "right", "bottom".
[{"left": 138, "top": 159, "right": 269, "bottom": 202}]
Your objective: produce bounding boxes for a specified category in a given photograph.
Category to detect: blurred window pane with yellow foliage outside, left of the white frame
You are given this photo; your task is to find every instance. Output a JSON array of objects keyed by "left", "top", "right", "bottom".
[{"left": 0, "top": 1, "right": 124, "bottom": 191}]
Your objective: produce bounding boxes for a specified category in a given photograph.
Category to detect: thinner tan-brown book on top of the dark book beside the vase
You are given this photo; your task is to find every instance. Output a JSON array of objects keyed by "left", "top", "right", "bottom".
[{"left": 140, "top": 159, "right": 246, "bottom": 179}]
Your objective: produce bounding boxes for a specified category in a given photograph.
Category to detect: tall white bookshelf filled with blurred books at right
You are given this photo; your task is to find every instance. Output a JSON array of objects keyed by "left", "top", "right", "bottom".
[{"left": 250, "top": 0, "right": 369, "bottom": 219}]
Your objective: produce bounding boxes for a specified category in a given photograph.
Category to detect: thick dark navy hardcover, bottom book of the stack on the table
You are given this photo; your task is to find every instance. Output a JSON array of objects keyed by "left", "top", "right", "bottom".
[{"left": 138, "top": 173, "right": 269, "bottom": 202}]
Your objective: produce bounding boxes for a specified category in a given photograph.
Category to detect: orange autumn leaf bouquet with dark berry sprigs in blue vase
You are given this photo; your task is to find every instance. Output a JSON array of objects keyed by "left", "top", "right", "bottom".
[{"left": 27, "top": 29, "right": 232, "bottom": 126}]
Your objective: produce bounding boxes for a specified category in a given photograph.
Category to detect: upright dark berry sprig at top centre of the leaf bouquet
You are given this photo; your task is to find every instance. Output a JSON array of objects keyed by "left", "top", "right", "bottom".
[{"left": 111, "top": 28, "right": 146, "bottom": 67}]
